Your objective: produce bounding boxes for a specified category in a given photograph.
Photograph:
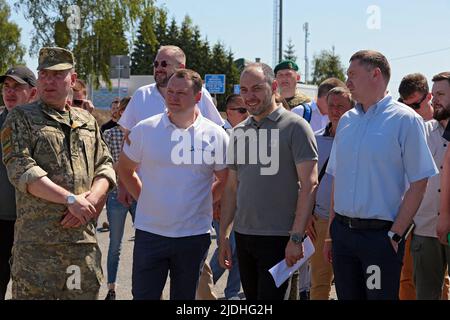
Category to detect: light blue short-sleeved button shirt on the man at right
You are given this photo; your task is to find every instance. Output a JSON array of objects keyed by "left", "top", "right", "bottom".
[{"left": 327, "top": 95, "right": 438, "bottom": 221}]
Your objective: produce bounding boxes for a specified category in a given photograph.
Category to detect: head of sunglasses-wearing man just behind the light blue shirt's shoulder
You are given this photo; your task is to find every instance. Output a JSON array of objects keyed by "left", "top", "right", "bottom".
[{"left": 398, "top": 73, "right": 433, "bottom": 121}]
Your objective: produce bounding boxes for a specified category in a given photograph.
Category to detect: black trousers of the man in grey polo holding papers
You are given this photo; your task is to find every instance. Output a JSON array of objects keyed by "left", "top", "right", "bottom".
[{"left": 235, "top": 232, "right": 289, "bottom": 300}]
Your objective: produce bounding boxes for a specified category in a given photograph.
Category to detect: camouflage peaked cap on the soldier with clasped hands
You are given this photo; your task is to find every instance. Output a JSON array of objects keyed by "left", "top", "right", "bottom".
[{"left": 38, "top": 47, "right": 75, "bottom": 70}]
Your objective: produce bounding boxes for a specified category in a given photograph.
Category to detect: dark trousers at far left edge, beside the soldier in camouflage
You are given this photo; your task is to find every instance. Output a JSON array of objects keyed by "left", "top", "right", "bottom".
[{"left": 0, "top": 220, "right": 15, "bottom": 300}]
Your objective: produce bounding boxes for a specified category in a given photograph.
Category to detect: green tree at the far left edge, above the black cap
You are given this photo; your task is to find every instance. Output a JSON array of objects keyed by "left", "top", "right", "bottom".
[{"left": 0, "top": 0, "right": 25, "bottom": 74}]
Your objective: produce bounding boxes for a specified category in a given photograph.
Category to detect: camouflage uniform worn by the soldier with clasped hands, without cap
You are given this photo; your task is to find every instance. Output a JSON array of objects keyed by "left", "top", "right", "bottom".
[{"left": 2, "top": 101, "right": 115, "bottom": 299}]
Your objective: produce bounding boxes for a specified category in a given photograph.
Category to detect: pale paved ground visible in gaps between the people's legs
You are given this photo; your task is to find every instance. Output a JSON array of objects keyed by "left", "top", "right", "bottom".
[{"left": 6, "top": 208, "right": 335, "bottom": 300}]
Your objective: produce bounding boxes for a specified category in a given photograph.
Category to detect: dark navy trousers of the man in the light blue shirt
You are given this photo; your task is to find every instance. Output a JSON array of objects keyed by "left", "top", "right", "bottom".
[{"left": 330, "top": 219, "right": 404, "bottom": 300}]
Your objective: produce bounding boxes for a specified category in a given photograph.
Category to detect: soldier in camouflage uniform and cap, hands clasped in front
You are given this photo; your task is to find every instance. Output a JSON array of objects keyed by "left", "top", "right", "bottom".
[{"left": 1, "top": 48, "right": 115, "bottom": 299}]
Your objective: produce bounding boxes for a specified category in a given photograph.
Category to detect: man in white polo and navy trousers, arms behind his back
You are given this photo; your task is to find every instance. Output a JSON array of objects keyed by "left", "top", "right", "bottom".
[{"left": 118, "top": 69, "right": 229, "bottom": 300}]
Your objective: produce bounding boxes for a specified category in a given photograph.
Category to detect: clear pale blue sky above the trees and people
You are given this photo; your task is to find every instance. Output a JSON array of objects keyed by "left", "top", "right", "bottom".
[{"left": 8, "top": 0, "right": 450, "bottom": 95}]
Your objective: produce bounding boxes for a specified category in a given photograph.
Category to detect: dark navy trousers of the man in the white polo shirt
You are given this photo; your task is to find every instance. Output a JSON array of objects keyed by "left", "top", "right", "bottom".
[{"left": 132, "top": 229, "right": 211, "bottom": 300}]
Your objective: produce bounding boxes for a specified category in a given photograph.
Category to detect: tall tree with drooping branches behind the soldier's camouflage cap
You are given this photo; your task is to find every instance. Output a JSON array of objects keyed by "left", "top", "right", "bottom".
[{"left": 15, "top": 0, "right": 154, "bottom": 86}]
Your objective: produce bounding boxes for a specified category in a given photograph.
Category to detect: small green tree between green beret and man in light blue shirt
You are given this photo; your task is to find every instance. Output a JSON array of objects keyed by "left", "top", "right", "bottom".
[{"left": 312, "top": 47, "right": 345, "bottom": 85}]
